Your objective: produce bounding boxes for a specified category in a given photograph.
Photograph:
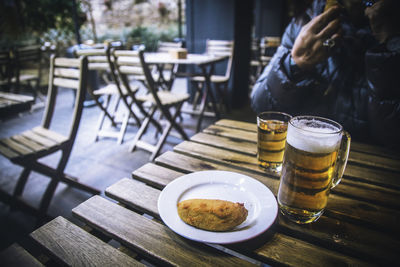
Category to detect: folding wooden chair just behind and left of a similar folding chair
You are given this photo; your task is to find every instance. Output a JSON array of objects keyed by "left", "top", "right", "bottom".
[{"left": 76, "top": 46, "right": 141, "bottom": 144}]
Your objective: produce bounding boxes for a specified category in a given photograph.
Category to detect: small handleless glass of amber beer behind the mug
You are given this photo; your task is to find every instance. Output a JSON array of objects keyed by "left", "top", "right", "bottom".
[{"left": 257, "top": 111, "right": 292, "bottom": 174}]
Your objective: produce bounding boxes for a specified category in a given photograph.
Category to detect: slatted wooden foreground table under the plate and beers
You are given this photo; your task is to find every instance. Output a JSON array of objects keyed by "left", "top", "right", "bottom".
[{"left": 0, "top": 120, "right": 400, "bottom": 266}]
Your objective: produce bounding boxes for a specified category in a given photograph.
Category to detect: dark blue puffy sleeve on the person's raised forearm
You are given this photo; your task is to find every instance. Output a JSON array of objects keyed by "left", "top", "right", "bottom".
[{"left": 251, "top": 20, "right": 314, "bottom": 113}]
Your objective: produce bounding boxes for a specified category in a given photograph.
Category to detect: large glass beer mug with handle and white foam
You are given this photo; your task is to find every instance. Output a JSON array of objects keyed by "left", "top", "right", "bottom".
[{"left": 278, "top": 116, "right": 351, "bottom": 224}]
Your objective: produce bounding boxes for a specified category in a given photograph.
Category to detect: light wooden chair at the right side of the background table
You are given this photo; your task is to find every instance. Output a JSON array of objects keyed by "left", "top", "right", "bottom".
[{"left": 191, "top": 40, "right": 234, "bottom": 110}]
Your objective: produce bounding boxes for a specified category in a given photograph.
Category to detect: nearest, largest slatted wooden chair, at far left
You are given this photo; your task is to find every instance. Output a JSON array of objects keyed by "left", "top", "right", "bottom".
[{"left": 0, "top": 56, "right": 100, "bottom": 222}]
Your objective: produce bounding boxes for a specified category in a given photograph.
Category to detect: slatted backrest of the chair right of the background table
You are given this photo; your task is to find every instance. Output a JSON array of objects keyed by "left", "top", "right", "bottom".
[{"left": 206, "top": 40, "right": 234, "bottom": 78}]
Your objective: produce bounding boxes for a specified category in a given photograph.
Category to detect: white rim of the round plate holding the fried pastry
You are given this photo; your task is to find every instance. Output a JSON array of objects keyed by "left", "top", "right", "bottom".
[{"left": 157, "top": 170, "right": 279, "bottom": 244}]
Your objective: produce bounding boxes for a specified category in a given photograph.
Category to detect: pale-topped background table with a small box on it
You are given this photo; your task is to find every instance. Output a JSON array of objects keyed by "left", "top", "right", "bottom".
[{"left": 145, "top": 52, "right": 228, "bottom": 132}]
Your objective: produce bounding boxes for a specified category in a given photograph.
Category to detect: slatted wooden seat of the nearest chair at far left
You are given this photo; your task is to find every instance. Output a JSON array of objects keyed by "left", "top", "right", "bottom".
[{"left": 0, "top": 126, "right": 68, "bottom": 160}]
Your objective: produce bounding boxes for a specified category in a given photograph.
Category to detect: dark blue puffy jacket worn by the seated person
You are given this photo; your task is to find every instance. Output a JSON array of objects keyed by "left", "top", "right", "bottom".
[{"left": 251, "top": 0, "right": 400, "bottom": 149}]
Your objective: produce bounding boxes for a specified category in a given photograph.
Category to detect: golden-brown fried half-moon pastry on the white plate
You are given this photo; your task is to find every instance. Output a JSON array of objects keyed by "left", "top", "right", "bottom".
[{"left": 178, "top": 199, "right": 248, "bottom": 231}]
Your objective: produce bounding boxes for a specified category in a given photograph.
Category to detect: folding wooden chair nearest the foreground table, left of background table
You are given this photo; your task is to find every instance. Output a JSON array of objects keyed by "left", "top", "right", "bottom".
[{"left": 114, "top": 50, "right": 189, "bottom": 161}]
